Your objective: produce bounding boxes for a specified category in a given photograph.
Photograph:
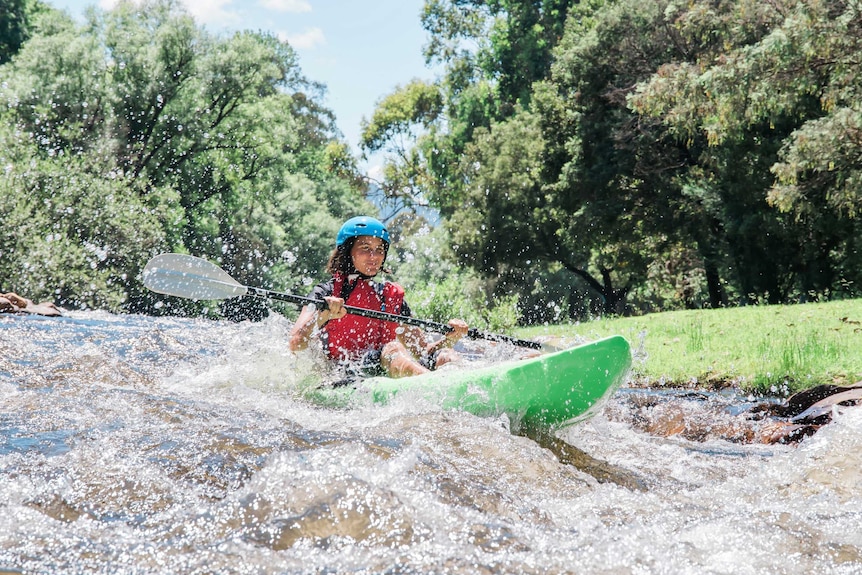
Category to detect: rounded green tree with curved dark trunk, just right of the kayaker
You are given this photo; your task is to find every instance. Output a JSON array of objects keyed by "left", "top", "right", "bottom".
[{"left": 447, "top": 106, "right": 638, "bottom": 319}]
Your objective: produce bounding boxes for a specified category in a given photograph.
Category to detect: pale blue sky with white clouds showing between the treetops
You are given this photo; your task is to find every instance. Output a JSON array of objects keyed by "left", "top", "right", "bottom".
[{"left": 47, "top": 0, "right": 442, "bottom": 171}]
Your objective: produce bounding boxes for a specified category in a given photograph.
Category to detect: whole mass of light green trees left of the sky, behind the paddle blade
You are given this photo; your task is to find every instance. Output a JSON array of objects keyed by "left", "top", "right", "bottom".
[{"left": 0, "top": 0, "right": 370, "bottom": 318}]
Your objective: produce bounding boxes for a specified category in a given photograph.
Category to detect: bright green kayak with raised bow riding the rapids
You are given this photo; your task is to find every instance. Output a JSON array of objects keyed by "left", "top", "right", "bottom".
[{"left": 307, "top": 336, "right": 631, "bottom": 427}]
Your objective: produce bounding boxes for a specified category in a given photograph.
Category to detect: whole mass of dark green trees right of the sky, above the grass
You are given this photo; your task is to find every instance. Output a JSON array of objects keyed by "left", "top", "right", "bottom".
[{"left": 417, "top": 0, "right": 859, "bottom": 313}]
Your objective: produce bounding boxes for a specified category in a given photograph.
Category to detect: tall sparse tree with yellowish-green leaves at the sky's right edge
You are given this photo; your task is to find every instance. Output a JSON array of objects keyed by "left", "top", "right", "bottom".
[{"left": 363, "top": 0, "right": 596, "bottom": 320}]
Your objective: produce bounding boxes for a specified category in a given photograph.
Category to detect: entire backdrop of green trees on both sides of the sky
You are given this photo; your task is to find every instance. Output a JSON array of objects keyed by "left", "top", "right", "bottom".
[{"left": 5, "top": 0, "right": 862, "bottom": 324}]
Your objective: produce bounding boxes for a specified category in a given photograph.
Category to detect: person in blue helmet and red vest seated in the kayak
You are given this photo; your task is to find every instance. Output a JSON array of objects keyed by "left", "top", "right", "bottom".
[{"left": 290, "top": 216, "right": 468, "bottom": 377}]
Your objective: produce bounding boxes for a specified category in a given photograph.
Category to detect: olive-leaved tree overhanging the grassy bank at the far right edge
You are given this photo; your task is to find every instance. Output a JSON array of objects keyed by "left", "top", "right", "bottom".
[{"left": 632, "top": 2, "right": 860, "bottom": 302}]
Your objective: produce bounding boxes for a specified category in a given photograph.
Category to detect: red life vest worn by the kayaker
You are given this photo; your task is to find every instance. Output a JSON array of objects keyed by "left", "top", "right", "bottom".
[{"left": 323, "top": 274, "right": 404, "bottom": 360}]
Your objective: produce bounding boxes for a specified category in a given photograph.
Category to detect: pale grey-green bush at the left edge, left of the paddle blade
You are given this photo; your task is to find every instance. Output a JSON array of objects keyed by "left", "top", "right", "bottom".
[{"left": 0, "top": 148, "right": 179, "bottom": 309}]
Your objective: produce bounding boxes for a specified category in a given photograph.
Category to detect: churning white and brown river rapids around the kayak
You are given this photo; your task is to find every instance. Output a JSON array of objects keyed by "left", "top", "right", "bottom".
[{"left": 0, "top": 313, "right": 862, "bottom": 574}]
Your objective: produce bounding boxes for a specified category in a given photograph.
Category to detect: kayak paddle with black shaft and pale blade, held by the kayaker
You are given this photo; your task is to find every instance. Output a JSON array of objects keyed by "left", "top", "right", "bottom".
[{"left": 143, "top": 254, "right": 544, "bottom": 349}]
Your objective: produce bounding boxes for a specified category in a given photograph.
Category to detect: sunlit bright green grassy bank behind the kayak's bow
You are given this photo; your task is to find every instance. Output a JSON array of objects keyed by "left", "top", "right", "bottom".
[{"left": 520, "top": 300, "right": 862, "bottom": 394}]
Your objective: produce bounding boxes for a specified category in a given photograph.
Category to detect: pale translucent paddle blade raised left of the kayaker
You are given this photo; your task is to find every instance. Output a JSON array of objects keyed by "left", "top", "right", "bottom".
[{"left": 143, "top": 254, "right": 248, "bottom": 300}]
